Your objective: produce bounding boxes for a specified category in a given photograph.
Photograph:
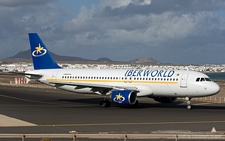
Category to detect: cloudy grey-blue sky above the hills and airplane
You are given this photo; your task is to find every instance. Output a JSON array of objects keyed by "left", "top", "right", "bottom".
[{"left": 0, "top": 0, "right": 225, "bottom": 64}]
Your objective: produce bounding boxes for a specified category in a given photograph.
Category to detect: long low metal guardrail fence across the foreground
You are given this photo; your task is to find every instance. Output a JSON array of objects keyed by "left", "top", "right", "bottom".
[{"left": 0, "top": 134, "right": 225, "bottom": 141}]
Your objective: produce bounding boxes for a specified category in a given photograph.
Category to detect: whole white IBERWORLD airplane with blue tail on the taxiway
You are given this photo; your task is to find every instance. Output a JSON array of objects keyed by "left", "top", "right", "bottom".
[{"left": 25, "top": 33, "right": 220, "bottom": 109}]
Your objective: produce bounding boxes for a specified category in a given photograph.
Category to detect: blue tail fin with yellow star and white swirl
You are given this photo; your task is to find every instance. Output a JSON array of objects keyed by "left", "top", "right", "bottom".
[{"left": 29, "top": 33, "right": 61, "bottom": 70}]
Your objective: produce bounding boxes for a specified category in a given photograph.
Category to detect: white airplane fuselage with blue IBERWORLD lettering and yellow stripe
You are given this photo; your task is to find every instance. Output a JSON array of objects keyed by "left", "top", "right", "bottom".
[{"left": 26, "top": 69, "right": 220, "bottom": 97}]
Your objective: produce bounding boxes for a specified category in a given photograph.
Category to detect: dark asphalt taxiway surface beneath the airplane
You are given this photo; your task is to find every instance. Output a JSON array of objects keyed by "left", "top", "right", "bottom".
[{"left": 0, "top": 85, "right": 225, "bottom": 134}]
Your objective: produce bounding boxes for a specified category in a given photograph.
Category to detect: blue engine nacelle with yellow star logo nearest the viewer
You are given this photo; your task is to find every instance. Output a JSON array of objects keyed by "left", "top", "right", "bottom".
[{"left": 111, "top": 90, "right": 137, "bottom": 105}]
